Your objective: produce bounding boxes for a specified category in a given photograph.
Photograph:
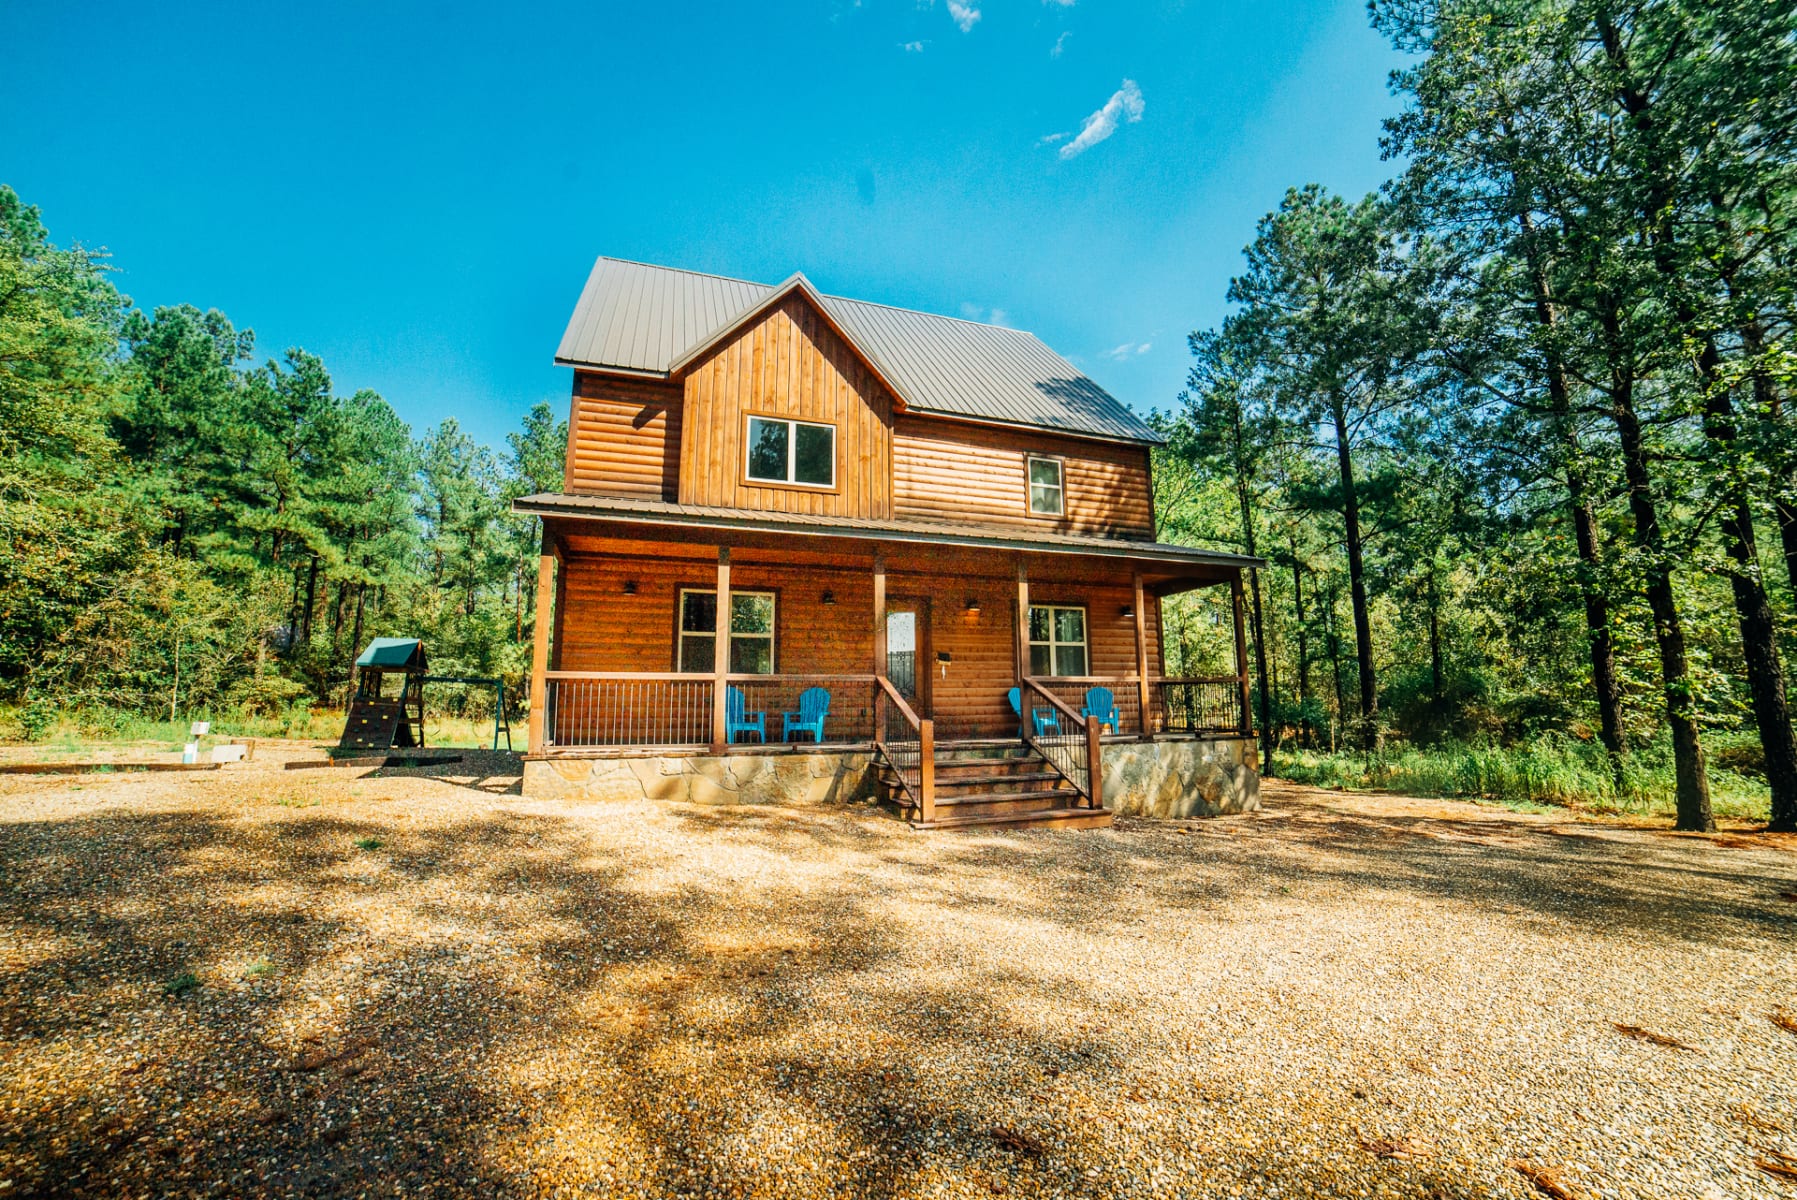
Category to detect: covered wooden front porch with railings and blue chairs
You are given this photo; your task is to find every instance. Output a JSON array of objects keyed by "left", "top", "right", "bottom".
[{"left": 513, "top": 498, "right": 1253, "bottom": 823}]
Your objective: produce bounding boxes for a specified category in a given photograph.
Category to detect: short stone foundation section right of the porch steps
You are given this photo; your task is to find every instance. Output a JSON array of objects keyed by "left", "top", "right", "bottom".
[{"left": 1103, "top": 738, "right": 1260, "bottom": 817}]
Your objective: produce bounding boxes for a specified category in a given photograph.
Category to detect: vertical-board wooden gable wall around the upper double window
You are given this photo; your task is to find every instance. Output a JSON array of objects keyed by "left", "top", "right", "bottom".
[{"left": 679, "top": 295, "right": 893, "bottom": 519}]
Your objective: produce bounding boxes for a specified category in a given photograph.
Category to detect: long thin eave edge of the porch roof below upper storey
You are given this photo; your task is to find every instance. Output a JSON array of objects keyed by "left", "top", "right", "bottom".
[{"left": 512, "top": 496, "right": 1267, "bottom": 569}]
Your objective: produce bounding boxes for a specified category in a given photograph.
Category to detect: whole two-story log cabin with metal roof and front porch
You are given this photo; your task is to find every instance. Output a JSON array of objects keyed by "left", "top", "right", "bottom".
[{"left": 514, "top": 259, "right": 1258, "bottom": 826}]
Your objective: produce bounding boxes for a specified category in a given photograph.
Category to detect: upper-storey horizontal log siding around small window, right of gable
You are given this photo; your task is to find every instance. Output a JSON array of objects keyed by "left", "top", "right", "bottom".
[{"left": 893, "top": 415, "right": 1154, "bottom": 537}]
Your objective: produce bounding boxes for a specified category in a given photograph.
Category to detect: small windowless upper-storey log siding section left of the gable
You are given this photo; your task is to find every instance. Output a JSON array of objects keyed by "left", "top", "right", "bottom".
[{"left": 564, "top": 370, "right": 685, "bottom": 499}]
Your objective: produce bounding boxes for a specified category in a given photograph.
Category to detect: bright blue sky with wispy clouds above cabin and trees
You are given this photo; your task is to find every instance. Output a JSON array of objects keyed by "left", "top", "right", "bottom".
[{"left": 0, "top": 0, "right": 1398, "bottom": 444}]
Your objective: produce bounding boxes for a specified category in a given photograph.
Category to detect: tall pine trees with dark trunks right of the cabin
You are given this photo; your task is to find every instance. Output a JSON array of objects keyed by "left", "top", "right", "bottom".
[{"left": 1157, "top": 0, "right": 1797, "bottom": 830}]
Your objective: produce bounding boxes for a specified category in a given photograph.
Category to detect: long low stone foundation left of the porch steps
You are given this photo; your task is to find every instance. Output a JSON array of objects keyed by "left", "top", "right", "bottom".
[{"left": 523, "top": 751, "right": 877, "bottom": 805}]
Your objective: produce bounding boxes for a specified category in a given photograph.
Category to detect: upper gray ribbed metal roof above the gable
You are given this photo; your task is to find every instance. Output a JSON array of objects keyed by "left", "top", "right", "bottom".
[{"left": 555, "top": 257, "right": 1161, "bottom": 442}]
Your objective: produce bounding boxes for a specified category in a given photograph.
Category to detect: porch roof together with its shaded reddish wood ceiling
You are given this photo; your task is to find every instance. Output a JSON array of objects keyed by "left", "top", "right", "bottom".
[{"left": 512, "top": 494, "right": 1265, "bottom": 589}]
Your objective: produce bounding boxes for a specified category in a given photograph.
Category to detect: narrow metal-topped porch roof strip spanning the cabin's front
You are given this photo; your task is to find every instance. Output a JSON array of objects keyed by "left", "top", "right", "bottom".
[{"left": 512, "top": 492, "right": 1267, "bottom": 569}]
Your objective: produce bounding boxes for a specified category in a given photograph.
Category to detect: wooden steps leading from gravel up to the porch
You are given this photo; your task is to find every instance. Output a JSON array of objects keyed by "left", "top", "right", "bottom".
[{"left": 879, "top": 742, "right": 1111, "bottom": 830}]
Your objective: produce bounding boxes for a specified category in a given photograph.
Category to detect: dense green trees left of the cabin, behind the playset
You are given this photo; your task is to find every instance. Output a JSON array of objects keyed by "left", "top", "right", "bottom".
[{"left": 0, "top": 187, "right": 566, "bottom": 735}]
